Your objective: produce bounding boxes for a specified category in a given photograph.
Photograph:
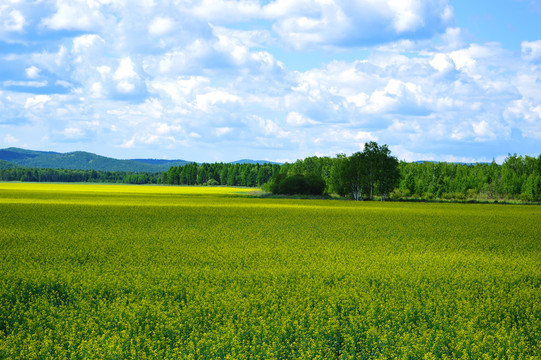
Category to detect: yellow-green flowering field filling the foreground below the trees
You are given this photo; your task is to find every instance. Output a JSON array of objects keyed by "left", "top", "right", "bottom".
[{"left": 0, "top": 183, "right": 541, "bottom": 359}]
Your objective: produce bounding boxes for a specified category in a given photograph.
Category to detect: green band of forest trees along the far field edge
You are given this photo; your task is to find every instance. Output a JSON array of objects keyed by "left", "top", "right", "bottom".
[{"left": 0, "top": 142, "right": 541, "bottom": 202}]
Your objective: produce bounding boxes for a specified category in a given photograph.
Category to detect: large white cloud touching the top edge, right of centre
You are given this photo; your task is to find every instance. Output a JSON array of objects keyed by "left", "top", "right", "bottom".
[{"left": 264, "top": 0, "right": 454, "bottom": 49}]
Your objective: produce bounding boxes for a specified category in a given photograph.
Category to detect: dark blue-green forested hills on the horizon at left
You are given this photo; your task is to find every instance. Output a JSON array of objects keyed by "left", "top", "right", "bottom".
[{"left": 0, "top": 148, "right": 188, "bottom": 172}]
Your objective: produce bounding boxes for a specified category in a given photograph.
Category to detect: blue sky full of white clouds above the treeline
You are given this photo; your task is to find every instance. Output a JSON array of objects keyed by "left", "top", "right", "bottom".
[{"left": 0, "top": 0, "right": 541, "bottom": 163}]
